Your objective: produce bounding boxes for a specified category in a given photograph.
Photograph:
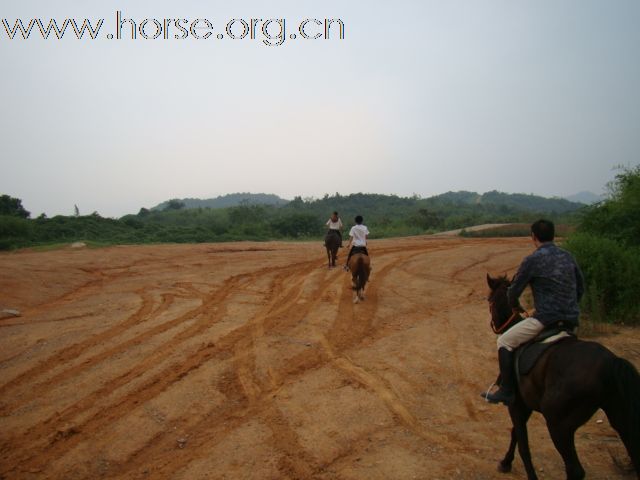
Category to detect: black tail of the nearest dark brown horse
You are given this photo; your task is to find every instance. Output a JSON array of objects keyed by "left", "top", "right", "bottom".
[{"left": 606, "top": 357, "right": 640, "bottom": 475}]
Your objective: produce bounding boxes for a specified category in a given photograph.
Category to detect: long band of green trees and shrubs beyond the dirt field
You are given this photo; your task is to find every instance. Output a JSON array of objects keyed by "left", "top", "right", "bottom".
[{"left": 0, "top": 192, "right": 578, "bottom": 248}]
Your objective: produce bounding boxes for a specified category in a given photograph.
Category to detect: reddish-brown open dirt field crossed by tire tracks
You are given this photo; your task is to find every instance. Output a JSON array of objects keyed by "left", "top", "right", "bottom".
[{"left": 0, "top": 237, "right": 640, "bottom": 480}]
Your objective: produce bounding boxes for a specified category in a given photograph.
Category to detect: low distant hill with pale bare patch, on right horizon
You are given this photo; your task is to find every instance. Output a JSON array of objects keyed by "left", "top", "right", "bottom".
[{"left": 426, "top": 190, "right": 584, "bottom": 213}]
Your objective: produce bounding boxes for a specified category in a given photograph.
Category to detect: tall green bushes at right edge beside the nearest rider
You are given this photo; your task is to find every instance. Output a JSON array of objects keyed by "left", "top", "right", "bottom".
[{"left": 566, "top": 166, "right": 640, "bottom": 323}]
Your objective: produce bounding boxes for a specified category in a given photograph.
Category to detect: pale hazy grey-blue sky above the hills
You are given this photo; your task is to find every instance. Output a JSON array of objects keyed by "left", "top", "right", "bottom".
[{"left": 0, "top": 0, "right": 640, "bottom": 217}]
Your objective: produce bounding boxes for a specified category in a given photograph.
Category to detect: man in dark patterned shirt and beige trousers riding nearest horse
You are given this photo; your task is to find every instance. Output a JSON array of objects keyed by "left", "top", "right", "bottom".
[{"left": 482, "top": 220, "right": 584, "bottom": 405}]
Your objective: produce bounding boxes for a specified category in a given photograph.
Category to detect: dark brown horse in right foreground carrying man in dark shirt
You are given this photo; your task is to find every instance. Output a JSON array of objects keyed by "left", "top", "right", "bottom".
[{"left": 487, "top": 275, "right": 640, "bottom": 480}]
